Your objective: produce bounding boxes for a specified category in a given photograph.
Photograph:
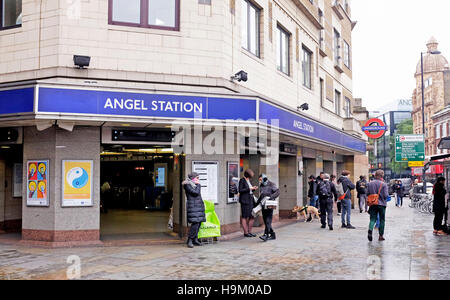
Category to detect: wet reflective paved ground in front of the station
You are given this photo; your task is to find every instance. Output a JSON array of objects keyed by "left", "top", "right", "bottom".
[{"left": 0, "top": 200, "right": 450, "bottom": 280}]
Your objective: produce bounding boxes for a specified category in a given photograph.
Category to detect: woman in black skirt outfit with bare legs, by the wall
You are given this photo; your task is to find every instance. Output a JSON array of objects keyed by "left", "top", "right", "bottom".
[{"left": 239, "top": 169, "right": 258, "bottom": 237}]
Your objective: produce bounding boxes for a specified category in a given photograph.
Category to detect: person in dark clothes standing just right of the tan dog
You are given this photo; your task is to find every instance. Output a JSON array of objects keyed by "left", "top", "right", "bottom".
[{"left": 317, "top": 174, "right": 337, "bottom": 231}]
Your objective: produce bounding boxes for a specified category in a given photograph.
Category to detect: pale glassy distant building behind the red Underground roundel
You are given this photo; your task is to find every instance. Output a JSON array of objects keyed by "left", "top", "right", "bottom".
[{"left": 369, "top": 99, "right": 412, "bottom": 179}]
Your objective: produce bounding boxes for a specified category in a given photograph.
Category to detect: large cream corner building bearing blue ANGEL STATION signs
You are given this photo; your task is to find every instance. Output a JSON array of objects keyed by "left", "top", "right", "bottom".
[{"left": 0, "top": 0, "right": 368, "bottom": 243}]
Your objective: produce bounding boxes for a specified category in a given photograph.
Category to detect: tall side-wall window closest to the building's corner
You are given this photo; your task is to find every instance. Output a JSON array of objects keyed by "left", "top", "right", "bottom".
[{"left": 242, "top": 0, "right": 261, "bottom": 57}]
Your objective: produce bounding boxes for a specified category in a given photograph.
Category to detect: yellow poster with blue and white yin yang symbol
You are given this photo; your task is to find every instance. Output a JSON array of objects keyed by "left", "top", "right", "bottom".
[{"left": 62, "top": 160, "right": 94, "bottom": 207}]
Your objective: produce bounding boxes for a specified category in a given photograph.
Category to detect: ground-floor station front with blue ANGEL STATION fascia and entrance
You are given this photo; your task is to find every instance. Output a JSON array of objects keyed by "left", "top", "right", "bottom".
[{"left": 0, "top": 84, "right": 367, "bottom": 246}]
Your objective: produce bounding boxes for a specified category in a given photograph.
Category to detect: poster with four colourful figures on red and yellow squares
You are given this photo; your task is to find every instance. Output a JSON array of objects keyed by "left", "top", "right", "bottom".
[{"left": 26, "top": 160, "right": 50, "bottom": 206}]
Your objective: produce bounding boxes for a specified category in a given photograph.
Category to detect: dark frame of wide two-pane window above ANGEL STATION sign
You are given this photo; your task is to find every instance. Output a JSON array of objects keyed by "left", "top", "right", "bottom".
[{"left": 108, "top": 0, "right": 180, "bottom": 31}]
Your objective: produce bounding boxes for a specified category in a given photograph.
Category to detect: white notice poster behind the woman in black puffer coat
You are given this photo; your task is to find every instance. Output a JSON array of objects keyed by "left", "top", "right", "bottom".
[{"left": 192, "top": 161, "right": 219, "bottom": 204}]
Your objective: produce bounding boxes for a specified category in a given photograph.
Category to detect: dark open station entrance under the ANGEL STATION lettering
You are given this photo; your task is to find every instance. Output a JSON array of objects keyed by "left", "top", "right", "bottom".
[{"left": 100, "top": 145, "right": 182, "bottom": 240}]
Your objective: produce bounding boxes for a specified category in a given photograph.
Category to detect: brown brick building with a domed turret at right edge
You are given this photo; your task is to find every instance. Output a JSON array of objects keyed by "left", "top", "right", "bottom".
[{"left": 412, "top": 37, "right": 450, "bottom": 156}]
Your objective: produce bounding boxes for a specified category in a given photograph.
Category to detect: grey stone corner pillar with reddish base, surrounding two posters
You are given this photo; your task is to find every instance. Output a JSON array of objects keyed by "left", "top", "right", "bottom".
[{"left": 22, "top": 127, "right": 100, "bottom": 246}]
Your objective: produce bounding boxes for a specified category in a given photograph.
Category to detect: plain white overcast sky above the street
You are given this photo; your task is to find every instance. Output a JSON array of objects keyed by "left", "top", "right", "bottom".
[{"left": 351, "top": 0, "right": 450, "bottom": 111}]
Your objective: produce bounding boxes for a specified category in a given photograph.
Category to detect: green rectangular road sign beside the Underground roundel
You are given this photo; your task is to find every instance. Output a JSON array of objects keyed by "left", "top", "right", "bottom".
[{"left": 395, "top": 134, "right": 425, "bottom": 162}]
